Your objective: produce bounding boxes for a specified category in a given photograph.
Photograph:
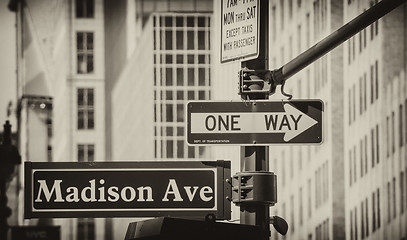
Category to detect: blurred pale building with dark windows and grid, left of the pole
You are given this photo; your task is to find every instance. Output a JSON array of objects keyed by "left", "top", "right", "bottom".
[{"left": 9, "top": 0, "right": 213, "bottom": 239}]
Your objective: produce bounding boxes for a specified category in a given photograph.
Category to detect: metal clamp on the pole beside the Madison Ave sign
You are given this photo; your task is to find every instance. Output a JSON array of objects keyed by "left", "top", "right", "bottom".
[{"left": 232, "top": 172, "right": 277, "bottom": 206}]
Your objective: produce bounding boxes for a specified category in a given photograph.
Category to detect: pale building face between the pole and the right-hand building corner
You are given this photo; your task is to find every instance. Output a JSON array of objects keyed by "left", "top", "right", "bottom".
[{"left": 256, "top": 0, "right": 345, "bottom": 240}]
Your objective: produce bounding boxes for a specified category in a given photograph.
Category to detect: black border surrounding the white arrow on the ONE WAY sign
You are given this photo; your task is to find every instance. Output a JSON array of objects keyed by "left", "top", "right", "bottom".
[{"left": 185, "top": 99, "right": 324, "bottom": 146}]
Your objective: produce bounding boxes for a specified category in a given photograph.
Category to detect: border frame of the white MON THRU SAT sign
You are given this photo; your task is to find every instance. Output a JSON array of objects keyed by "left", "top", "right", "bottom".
[{"left": 220, "top": 0, "right": 261, "bottom": 63}]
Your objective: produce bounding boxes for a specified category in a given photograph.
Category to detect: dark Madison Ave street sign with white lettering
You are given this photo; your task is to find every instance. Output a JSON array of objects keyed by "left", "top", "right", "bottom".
[{"left": 25, "top": 161, "right": 231, "bottom": 219}]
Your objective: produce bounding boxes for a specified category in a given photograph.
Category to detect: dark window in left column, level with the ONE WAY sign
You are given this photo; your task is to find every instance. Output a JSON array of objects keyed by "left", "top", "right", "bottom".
[{"left": 77, "top": 88, "right": 95, "bottom": 129}]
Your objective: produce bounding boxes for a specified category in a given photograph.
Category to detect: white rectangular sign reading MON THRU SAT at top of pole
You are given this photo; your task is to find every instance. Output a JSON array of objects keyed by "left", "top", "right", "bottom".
[{"left": 221, "top": 0, "right": 260, "bottom": 63}]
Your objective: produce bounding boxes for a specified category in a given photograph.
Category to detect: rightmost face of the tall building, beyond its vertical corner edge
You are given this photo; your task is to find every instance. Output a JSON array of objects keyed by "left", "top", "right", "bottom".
[{"left": 343, "top": 1, "right": 407, "bottom": 240}]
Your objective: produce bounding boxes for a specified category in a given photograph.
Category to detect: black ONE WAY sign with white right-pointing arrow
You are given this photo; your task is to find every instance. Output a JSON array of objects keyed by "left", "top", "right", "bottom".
[{"left": 187, "top": 100, "right": 323, "bottom": 145}]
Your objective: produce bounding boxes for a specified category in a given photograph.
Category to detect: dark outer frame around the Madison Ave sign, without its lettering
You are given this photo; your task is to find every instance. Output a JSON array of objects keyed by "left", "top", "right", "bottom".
[{"left": 24, "top": 160, "right": 231, "bottom": 220}]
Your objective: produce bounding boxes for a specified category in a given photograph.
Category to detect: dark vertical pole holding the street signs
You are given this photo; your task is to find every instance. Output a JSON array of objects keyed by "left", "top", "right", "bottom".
[{"left": 240, "top": 0, "right": 270, "bottom": 236}]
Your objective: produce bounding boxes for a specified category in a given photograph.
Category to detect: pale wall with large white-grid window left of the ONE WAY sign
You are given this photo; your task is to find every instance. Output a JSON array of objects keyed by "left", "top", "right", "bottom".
[{"left": 106, "top": 1, "right": 213, "bottom": 236}]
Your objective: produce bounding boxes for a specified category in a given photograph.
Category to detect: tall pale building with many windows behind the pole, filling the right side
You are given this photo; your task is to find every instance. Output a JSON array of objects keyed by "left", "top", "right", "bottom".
[{"left": 212, "top": 0, "right": 407, "bottom": 239}]
